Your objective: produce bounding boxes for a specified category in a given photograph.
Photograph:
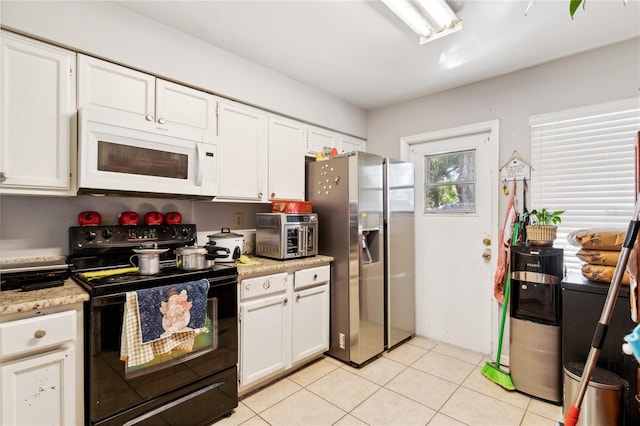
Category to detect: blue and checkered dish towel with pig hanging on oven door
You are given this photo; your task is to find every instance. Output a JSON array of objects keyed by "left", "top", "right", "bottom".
[{"left": 120, "top": 279, "right": 209, "bottom": 367}]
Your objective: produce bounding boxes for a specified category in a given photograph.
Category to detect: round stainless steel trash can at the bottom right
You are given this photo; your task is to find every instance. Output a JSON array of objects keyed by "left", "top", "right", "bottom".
[{"left": 563, "top": 362, "right": 629, "bottom": 426}]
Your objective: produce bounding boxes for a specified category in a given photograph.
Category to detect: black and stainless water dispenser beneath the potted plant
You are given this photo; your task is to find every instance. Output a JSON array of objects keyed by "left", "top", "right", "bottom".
[{"left": 509, "top": 246, "right": 564, "bottom": 404}]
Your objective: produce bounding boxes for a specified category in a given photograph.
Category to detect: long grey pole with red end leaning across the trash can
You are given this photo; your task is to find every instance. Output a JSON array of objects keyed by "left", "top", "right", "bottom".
[{"left": 556, "top": 195, "right": 640, "bottom": 426}]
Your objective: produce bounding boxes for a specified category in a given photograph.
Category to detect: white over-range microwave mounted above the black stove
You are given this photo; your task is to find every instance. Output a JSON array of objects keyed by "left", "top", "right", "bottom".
[{"left": 78, "top": 108, "right": 218, "bottom": 198}]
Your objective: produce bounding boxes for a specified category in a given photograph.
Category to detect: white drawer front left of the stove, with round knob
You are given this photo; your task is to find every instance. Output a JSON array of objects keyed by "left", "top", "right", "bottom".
[{"left": 0, "top": 311, "right": 76, "bottom": 357}]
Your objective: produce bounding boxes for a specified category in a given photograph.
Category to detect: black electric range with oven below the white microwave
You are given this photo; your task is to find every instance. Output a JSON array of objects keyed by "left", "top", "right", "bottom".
[{"left": 69, "top": 224, "right": 238, "bottom": 426}]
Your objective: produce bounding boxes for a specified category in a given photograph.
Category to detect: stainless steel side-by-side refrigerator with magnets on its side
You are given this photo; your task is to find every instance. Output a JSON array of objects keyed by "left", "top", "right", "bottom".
[{"left": 307, "top": 151, "right": 415, "bottom": 366}]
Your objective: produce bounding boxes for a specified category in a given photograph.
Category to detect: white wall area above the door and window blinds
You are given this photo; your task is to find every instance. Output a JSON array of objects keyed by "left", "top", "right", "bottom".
[{"left": 367, "top": 38, "right": 640, "bottom": 164}]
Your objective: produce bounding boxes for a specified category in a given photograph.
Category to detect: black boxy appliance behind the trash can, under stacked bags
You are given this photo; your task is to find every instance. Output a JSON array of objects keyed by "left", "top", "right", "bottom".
[{"left": 561, "top": 273, "right": 640, "bottom": 426}]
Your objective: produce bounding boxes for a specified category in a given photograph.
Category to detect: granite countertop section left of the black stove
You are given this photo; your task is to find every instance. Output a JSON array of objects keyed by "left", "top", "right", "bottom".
[{"left": 0, "top": 278, "right": 89, "bottom": 316}]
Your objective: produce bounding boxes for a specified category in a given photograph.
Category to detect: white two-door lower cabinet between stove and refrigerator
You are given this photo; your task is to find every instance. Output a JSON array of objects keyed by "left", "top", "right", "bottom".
[{"left": 238, "top": 265, "right": 330, "bottom": 394}]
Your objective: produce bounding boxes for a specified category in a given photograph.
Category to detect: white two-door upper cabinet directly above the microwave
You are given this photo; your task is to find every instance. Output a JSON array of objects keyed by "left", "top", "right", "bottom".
[{"left": 78, "top": 54, "right": 217, "bottom": 142}]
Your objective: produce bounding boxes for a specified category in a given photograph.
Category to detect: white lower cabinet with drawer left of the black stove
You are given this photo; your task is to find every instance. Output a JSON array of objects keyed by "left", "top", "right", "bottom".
[{"left": 0, "top": 310, "right": 83, "bottom": 426}]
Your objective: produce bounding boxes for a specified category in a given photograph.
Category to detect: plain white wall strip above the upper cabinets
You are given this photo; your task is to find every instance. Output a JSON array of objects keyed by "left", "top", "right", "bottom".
[{"left": 0, "top": 0, "right": 367, "bottom": 139}]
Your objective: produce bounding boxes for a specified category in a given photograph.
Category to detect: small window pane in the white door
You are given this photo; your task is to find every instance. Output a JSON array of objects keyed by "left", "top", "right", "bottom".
[{"left": 424, "top": 149, "right": 476, "bottom": 214}]
